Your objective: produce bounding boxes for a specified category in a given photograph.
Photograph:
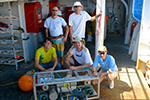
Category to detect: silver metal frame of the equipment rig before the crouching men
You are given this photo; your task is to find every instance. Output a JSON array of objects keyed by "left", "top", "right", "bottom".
[{"left": 33, "top": 69, "right": 100, "bottom": 100}]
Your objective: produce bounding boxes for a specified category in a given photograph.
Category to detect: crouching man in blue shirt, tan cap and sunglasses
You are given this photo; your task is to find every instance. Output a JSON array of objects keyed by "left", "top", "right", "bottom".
[{"left": 92, "top": 46, "right": 118, "bottom": 89}]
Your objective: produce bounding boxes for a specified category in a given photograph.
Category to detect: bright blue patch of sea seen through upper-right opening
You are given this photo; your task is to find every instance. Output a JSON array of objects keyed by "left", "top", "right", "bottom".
[{"left": 132, "top": 0, "right": 143, "bottom": 22}]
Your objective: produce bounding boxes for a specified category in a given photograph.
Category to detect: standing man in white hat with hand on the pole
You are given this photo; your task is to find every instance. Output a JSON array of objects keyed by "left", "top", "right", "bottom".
[{"left": 69, "top": 1, "right": 101, "bottom": 42}]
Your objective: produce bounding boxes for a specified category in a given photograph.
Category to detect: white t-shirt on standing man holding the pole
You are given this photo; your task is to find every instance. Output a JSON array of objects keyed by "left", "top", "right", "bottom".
[{"left": 69, "top": 11, "right": 91, "bottom": 38}]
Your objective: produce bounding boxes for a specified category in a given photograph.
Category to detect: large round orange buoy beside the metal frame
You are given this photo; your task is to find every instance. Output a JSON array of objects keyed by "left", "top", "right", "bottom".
[{"left": 18, "top": 75, "right": 33, "bottom": 91}]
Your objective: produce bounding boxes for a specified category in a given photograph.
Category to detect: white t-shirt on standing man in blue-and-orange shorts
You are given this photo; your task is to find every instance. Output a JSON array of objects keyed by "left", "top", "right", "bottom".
[{"left": 44, "top": 16, "right": 67, "bottom": 37}]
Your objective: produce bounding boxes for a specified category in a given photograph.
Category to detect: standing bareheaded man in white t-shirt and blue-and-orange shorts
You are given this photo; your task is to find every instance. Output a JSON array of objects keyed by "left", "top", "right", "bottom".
[{"left": 44, "top": 6, "right": 69, "bottom": 68}]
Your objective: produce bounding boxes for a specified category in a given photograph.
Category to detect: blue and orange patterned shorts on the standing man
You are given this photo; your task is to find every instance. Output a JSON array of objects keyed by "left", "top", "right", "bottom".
[{"left": 53, "top": 38, "right": 65, "bottom": 57}]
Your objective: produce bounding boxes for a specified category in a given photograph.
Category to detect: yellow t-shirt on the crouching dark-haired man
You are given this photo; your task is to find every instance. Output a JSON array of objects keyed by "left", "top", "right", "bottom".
[{"left": 35, "top": 46, "right": 57, "bottom": 63}]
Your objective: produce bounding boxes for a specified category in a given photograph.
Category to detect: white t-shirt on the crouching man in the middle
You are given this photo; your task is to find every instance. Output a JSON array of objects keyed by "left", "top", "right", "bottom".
[{"left": 71, "top": 48, "right": 93, "bottom": 65}]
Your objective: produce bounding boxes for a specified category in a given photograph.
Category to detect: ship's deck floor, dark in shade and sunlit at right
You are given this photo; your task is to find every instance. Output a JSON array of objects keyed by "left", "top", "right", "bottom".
[{"left": 0, "top": 36, "right": 150, "bottom": 100}]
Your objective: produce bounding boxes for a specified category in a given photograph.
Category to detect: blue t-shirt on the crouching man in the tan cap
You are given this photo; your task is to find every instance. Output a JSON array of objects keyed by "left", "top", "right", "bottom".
[{"left": 92, "top": 54, "right": 118, "bottom": 73}]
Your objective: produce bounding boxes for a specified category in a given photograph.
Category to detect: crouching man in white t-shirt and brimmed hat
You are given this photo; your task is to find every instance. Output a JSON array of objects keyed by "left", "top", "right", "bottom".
[{"left": 65, "top": 36, "right": 93, "bottom": 70}]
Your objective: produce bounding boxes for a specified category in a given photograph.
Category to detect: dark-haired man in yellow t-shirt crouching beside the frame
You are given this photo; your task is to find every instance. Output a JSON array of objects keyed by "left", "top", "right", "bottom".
[{"left": 35, "top": 37, "right": 61, "bottom": 71}]
